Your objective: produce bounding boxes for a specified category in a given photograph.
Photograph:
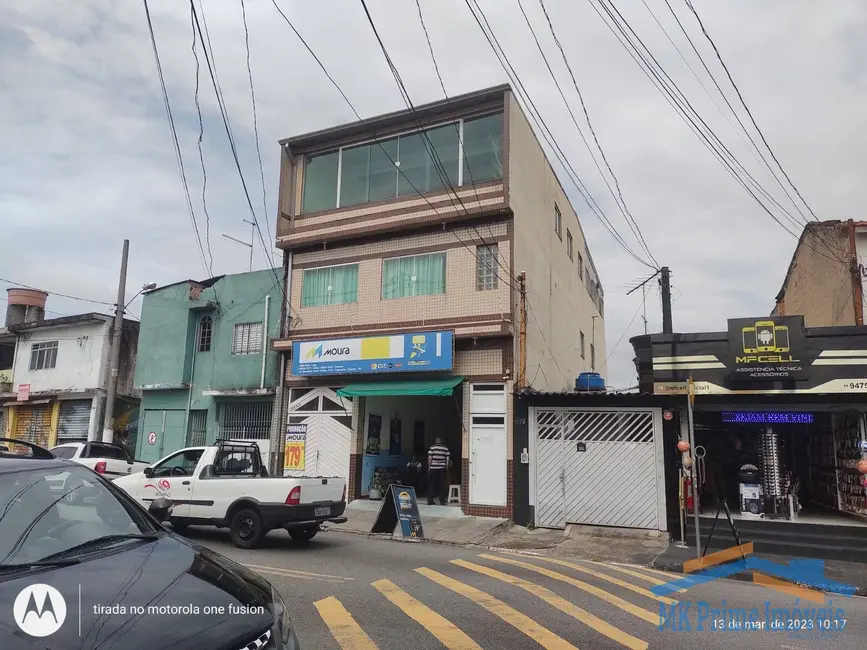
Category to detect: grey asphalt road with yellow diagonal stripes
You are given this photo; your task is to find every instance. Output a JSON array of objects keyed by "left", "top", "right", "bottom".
[{"left": 190, "top": 529, "right": 867, "bottom": 650}]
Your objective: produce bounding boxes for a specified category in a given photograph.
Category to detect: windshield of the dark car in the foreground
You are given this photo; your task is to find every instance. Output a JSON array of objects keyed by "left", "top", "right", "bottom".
[{"left": 0, "top": 464, "right": 156, "bottom": 568}]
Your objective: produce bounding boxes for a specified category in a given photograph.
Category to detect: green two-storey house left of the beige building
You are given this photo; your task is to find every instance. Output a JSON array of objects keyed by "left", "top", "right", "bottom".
[{"left": 135, "top": 269, "right": 283, "bottom": 462}]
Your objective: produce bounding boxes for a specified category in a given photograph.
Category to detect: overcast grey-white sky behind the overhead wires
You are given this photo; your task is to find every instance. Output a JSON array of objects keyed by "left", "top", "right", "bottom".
[{"left": 0, "top": 0, "right": 867, "bottom": 387}]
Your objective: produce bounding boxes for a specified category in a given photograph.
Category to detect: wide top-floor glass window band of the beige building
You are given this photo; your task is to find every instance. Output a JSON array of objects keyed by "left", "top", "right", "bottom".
[{"left": 302, "top": 113, "right": 503, "bottom": 213}]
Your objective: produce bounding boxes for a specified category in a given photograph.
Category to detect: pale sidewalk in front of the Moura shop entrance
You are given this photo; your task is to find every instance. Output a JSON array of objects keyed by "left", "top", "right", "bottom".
[{"left": 328, "top": 499, "right": 509, "bottom": 545}]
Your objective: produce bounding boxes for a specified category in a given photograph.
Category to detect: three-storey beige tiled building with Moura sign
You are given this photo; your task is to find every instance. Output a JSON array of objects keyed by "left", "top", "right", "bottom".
[{"left": 274, "top": 86, "right": 606, "bottom": 517}]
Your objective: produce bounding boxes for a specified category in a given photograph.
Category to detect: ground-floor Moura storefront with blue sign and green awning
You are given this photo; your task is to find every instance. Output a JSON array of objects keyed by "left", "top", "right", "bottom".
[{"left": 284, "top": 330, "right": 511, "bottom": 516}]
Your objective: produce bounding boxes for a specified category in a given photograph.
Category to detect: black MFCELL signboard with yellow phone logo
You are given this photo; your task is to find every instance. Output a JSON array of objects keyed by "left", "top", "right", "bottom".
[{"left": 728, "top": 316, "right": 811, "bottom": 381}]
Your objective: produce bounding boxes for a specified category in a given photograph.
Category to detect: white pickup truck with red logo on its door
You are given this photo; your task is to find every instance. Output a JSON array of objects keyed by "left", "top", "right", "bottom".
[{"left": 114, "top": 441, "right": 346, "bottom": 548}]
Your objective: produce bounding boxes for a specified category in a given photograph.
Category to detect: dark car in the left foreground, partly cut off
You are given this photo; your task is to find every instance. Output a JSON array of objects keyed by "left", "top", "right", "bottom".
[{"left": 0, "top": 438, "right": 299, "bottom": 650}]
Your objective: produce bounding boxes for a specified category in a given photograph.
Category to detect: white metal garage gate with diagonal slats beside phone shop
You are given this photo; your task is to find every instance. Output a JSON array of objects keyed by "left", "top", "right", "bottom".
[{"left": 530, "top": 407, "right": 666, "bottom": 530}]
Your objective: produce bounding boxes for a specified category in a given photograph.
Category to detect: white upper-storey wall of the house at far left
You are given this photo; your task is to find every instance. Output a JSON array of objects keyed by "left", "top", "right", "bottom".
[{"left": 13, "top": 323, "right": 111, "bottom": 393}]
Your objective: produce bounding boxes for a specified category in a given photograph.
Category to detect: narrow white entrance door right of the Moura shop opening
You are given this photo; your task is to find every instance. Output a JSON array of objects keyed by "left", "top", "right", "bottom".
[{"left": 470, "top": 415, "right": 506, "bottom": 506}]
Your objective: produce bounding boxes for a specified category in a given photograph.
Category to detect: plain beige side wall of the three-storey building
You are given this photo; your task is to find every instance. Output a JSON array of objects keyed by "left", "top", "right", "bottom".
[{"left": 508, "top": 93, "right": 606, "bottom": 391}]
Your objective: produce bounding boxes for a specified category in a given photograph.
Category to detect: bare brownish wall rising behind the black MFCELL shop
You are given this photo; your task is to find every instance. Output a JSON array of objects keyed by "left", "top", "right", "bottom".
[{"left": 774, "top": 223, "right": 855, "bottom": 327}]
